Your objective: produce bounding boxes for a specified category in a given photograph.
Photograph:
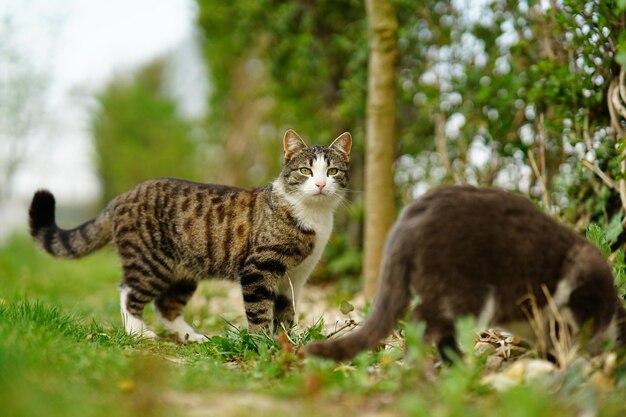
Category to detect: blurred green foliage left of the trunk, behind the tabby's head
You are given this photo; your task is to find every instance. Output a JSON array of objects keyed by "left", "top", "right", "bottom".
[{"left": 198, "top": 0, "right": 367, "bottom": 277}]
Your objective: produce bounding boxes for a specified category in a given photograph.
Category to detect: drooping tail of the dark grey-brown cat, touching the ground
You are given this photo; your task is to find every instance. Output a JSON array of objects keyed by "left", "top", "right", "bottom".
[{"left": 304, "top": 221, "right": 413, "bottom": 361}]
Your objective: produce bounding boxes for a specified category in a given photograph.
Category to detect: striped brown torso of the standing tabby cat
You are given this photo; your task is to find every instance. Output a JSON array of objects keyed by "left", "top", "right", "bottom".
[{"left": 110, "top": 178, "right": 266, "bottom": 276}]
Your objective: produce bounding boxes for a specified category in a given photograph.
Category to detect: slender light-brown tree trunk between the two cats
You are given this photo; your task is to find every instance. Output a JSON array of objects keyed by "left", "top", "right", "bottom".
[{"left": 363, "top": 0, "right": 398, "bottom": 297}]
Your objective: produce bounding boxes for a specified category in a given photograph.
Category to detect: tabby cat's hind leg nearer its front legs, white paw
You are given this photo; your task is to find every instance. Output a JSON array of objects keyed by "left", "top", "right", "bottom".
[{"left": 154, "top": 281, "right": 209, "bottom": 343}]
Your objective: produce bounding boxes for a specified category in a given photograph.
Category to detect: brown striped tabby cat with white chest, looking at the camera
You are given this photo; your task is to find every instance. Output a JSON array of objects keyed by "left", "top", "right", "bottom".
[{"left": 29, "top": 130, "right": 352, "bottom": 342}]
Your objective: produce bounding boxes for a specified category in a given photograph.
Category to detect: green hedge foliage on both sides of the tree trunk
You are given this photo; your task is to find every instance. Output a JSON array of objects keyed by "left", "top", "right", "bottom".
[{"left": 193, "top": 0, "right": 626, "bottom": 288}]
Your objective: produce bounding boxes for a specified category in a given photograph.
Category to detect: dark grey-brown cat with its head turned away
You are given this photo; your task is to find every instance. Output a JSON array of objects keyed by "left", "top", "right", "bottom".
[{"left": 305, "top": 187, "right": 626, "bottom": 360}]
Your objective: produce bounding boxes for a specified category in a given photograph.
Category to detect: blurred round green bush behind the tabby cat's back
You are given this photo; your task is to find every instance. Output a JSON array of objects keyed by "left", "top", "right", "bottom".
[{"left": 91, "top": 61, "right": 198, "bottom": 202}]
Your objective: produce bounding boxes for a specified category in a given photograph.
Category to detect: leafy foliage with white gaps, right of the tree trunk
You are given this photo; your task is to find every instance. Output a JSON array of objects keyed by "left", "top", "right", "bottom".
[{"left": 398, "top": 0, "right": 623, "bottom": 213}]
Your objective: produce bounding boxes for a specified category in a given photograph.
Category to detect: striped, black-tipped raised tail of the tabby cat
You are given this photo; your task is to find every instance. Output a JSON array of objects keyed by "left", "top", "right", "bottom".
[{"left": 28, "top": 190, "right": 112, "bottom": 258}]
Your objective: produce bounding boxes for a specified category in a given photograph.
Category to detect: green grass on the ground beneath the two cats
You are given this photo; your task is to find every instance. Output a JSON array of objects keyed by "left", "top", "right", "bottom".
[{"left": 0, "top": 237, "right": 626, "bottom": 417}]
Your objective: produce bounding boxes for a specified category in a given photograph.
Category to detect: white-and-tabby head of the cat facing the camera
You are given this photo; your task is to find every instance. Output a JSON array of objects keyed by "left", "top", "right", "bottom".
[{"left": 281, "top": 130, "right": 352, "bottom": 203}]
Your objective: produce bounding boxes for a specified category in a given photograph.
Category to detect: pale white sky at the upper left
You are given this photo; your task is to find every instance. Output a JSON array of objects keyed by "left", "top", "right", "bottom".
[{"left": 0, "top": 0, "right": 196, "bottom": 201}]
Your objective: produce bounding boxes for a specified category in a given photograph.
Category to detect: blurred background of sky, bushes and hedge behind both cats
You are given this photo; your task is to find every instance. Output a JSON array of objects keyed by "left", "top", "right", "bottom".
[{"left": 0, "top": 0, "right": 626, "bottom": 286}]
